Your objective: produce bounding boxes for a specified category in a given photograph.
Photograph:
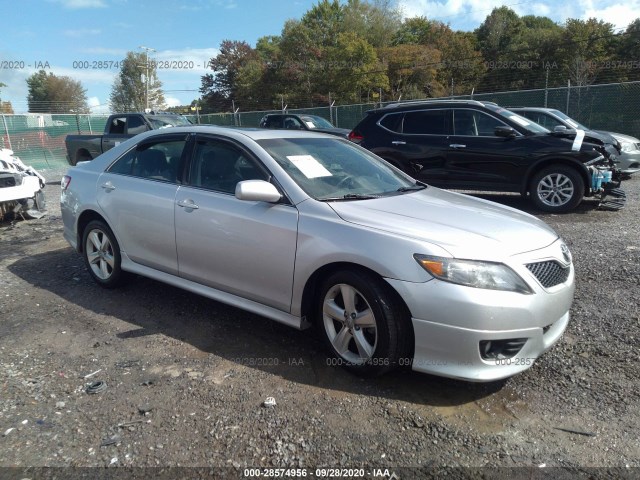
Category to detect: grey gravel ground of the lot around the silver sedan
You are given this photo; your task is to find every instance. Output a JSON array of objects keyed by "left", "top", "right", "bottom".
[{"left": 0, "top": 167, "right": 640, "bottom": 479}]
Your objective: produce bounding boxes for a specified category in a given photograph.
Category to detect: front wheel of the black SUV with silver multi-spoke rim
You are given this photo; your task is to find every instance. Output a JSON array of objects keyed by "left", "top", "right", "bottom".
[{"left": 529, "top": 165, "right": 585, "bottom": 213}]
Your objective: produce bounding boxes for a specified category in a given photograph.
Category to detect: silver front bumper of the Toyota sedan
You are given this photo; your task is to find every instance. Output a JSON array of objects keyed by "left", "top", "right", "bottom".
[{"left": 387, "top": 241, "right": 575, "bottom": 382}]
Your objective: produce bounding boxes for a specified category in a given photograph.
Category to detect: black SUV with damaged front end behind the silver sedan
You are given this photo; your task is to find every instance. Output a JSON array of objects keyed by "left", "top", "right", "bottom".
[{"left": 349, "top": 100, "right": 624, "bottom": 212}]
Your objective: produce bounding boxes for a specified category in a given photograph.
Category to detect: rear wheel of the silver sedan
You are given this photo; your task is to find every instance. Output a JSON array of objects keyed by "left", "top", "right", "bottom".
[{"left": 82, "top": 220, "right": 125, "bottom": 289}]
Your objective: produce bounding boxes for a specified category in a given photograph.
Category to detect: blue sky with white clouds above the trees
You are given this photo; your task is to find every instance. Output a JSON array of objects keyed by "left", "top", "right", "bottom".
[{"left": 0, "top": 0, "right": 640, "bottom": 113}]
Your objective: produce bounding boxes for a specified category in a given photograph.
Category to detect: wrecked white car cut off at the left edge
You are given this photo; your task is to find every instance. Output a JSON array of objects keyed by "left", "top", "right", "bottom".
[{"left": 0, "top": 148, "right": 46, "bottom": 220}]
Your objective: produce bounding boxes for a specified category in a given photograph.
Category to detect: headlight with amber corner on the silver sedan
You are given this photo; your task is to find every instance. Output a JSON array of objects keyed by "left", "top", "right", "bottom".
[{"left": 413, "top": 253, "right": 533, "bottom": 294}]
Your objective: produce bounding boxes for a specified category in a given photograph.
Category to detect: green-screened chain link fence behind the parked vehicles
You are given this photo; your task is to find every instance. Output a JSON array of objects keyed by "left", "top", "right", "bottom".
[{"left": 5, "top": 82, "right": 640, "bottom": 169}]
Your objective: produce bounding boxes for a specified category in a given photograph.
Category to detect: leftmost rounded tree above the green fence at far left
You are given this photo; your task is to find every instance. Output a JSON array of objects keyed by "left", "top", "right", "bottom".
[{"left": 27, "top": 70, "right": 89, "bottom": 113}]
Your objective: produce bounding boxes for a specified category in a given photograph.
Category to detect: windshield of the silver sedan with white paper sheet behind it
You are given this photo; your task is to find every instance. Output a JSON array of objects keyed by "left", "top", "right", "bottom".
[{"left": 258, "top": 138, "right": 424, "bottom": 201}]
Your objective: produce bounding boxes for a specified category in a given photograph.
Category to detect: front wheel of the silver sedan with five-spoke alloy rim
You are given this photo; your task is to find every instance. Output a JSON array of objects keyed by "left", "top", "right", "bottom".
[{"left": 316, "top": 270, "right": 408, "bottom": 376}]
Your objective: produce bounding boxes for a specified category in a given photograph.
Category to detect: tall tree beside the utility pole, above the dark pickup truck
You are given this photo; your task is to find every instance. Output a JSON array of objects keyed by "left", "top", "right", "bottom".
[{"left": 109, "top": 52, "right": 166, "bottom": 113}]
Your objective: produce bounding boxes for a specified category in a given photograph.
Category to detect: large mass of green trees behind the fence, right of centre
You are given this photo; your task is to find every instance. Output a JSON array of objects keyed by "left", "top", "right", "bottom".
[{"left": 201, "top": 0, "right": 640, "bottom": 112}]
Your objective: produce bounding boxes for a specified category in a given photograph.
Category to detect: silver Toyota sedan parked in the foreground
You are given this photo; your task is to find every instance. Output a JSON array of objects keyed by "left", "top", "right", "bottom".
[{"left": 61, "top": 126, "right": 574, "bottom": 381}]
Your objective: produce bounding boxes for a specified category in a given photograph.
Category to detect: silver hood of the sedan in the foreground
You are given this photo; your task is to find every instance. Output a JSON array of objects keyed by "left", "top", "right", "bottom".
[{"left": 329, "top": 187, "right": 558, "bottom": 260}]
